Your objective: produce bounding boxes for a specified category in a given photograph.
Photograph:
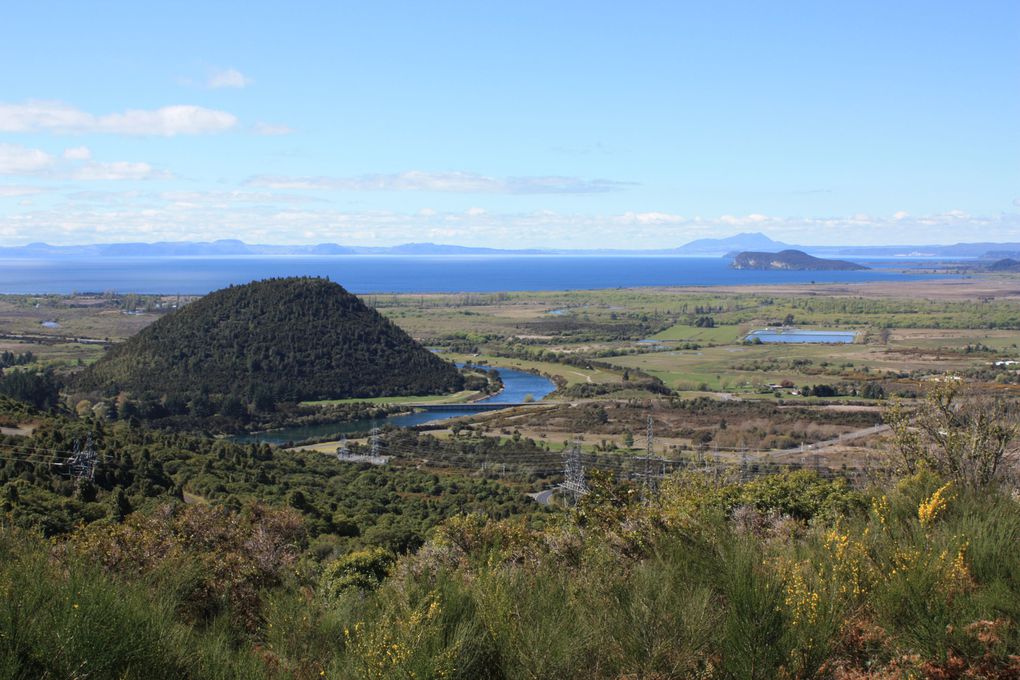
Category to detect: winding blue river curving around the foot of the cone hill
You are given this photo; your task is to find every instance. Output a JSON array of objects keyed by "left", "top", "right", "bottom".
[{"left": 231, "top": 366, "right": 556, "bottom": 444}]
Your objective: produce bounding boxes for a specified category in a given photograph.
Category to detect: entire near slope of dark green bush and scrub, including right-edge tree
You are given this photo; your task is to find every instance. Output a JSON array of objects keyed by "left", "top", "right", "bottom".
[{"left": 0, "top": 380, "right": 1020, "bottom": 680}]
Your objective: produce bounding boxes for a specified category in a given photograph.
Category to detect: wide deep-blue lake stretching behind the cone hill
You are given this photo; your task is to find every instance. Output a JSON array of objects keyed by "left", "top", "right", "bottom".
[{"left": 0, "top": 255, "right": 932, "bottom": 295}]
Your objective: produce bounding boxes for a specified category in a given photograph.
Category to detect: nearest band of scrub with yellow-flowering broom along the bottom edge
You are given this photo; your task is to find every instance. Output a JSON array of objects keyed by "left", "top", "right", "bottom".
[{"left": 0, "top": 464, "right": 1020, "bottom": 678}]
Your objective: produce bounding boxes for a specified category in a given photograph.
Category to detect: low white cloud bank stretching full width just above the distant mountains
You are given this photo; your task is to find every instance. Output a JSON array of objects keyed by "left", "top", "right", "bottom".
[{"left": 0, "top": 193, "right": 1020, "bottom": 249}]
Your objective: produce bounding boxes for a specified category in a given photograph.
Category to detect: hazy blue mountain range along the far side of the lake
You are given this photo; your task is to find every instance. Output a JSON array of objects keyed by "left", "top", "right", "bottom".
[{"left": 0, "top": 232, "right": 1020, "bottom": 259}]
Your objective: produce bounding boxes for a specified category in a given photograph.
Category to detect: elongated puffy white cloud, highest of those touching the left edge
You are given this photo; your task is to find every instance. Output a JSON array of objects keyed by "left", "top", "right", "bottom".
[{"left": 0, "top": 101, "right": 238, "bottom": 137}]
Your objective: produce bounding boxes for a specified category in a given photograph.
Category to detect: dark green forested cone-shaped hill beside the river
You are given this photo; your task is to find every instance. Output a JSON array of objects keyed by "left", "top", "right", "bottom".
[{"left": 75, "top": 278, "right": 463, "bottom": 407}]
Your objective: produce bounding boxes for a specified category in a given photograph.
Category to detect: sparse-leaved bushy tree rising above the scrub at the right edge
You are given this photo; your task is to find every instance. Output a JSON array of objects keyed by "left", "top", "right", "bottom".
[{"left": 887, "top": 376, "right": 1020, "bottom": 487}]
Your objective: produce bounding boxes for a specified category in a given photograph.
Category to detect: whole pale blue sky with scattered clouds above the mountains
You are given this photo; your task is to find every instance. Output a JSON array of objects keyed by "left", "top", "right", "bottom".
[{"left": 0, "top": 1, "right": 1020, "bottom": 248}]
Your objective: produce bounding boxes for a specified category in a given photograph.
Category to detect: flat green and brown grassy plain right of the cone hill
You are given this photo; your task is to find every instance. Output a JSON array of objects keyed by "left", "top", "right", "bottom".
[{"left": 357, "top": 277, "right": 1020, "bottom": 464}]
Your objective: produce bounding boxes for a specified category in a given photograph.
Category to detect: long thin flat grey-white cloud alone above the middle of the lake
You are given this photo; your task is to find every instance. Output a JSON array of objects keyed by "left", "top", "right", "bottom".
[{"left": 247, "top": 170, "right": 632, "bottom": 194}]
